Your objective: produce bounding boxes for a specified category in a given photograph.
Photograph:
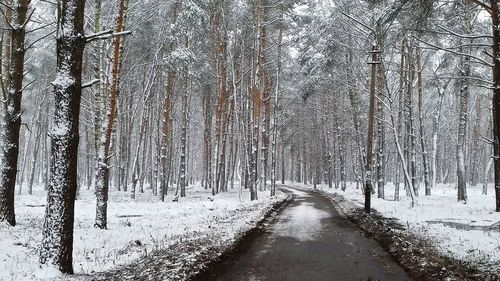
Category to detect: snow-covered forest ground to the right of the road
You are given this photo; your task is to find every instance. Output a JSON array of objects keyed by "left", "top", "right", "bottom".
[{"left": 292, "top": 184, "right": 500, "bottom": 270}]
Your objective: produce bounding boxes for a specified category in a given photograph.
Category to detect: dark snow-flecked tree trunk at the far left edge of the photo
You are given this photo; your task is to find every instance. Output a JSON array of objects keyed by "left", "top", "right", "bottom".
[{"left": 0, "top": 0, "right": 31, "bottom": 226}]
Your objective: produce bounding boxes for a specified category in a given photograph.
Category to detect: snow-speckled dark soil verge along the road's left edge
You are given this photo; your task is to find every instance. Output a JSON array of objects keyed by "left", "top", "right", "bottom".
[{"left": 82, "top": 192, "right": 292, "bottom": 281}]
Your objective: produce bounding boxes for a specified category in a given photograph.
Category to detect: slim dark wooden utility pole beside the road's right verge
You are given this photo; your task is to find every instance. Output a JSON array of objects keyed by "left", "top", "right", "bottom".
[{"left": 365, "top": 44, "right": 380, "bottom": 213}]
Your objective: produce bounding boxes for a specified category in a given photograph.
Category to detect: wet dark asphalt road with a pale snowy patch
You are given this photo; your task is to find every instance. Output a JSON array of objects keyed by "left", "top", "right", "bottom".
[{"left": 206, "top": 186, "right": 411, "bottom": 281}]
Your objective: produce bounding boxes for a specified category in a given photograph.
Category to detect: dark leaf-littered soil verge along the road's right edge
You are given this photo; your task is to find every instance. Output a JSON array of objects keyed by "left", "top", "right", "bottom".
[{"left": 323, "top": 193, "right": 500, "bottom": 281}]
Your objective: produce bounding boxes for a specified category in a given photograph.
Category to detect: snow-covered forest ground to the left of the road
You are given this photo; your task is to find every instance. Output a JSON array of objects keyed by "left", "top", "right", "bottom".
[{"left": 0, "top": 183, "right": 286, "bottom": 281}]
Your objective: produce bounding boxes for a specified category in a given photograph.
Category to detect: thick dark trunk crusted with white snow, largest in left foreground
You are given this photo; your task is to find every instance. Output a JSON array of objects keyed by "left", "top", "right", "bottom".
[{"left": 40, "top": 0, "right": 85, "bottom": 274}]
